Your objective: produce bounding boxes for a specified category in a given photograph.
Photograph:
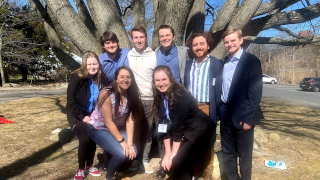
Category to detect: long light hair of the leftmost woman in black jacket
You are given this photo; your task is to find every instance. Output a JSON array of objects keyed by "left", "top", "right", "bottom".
[{"left": 74, "top": 51, "right": 108, "bottom": 89}]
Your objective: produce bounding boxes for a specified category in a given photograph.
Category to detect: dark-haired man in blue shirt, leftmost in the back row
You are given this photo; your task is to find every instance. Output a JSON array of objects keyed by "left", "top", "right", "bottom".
[{"left": 99, "top": 31, "right": 130, "bottom": 83}]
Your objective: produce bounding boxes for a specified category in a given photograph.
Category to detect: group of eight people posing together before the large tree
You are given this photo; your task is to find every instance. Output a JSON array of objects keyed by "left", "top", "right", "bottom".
[{"left": 67, "top": 25, "right": 262, "bottom": 180}]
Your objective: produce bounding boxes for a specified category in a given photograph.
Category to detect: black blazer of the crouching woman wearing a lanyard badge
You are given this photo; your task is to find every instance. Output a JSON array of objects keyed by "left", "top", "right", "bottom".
[{"left": 159, "top": 89, "right": 215, "bottom": 143}]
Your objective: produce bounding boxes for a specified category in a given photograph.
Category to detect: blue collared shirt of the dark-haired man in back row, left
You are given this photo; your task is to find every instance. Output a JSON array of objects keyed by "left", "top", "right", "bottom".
[{"left": 99, "top": 48, "right": 130, "bottom": 83}]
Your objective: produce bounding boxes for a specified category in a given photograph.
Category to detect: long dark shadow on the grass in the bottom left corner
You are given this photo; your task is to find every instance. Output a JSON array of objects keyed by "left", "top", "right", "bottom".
[{"left": 0, "top": 142, "right": 61, "bottom": 180}]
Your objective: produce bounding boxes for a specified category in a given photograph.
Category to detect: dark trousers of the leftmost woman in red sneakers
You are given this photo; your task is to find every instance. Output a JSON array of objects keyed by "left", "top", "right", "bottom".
[{"left": 73, "top": 121, "right": 96, "bottom": 169}]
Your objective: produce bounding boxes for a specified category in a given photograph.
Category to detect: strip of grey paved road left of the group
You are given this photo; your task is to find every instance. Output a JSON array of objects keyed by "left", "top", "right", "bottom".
[{"left": 0, "top": 89, "right": 67, "bottom": 103}]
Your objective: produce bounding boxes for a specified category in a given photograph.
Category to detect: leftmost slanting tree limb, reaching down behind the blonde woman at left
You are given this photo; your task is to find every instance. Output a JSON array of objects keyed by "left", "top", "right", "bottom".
[{"left": 29, "top": 0, "right": 80, "bottom": 70}]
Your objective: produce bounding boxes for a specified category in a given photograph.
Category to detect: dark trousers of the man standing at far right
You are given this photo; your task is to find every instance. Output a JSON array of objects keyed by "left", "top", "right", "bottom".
[{"left": 220, "top": 104, "right": 254, "bottom": 180}]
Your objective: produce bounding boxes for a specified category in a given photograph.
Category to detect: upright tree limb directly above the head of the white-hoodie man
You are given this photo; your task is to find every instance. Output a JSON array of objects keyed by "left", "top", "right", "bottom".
[{"left": 132, "top": 0, "right": 147, "bottom": 29}]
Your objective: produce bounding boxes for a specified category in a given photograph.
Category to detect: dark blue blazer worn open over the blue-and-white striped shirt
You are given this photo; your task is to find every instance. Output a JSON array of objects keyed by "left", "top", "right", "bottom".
[{"left": 184, "top": 56, "right": 221, "bottom": 122}]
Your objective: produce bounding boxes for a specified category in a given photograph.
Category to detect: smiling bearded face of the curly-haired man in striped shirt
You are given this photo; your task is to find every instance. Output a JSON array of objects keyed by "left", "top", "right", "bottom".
[{"left": 192, "top": 36, "right": 210, "bottom": 60}]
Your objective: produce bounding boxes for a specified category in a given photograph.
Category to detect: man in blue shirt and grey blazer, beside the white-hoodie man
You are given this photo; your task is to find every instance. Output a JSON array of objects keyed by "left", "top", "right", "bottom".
[{"left": 155, "top": 25, "right": 189, "bottom": 84}]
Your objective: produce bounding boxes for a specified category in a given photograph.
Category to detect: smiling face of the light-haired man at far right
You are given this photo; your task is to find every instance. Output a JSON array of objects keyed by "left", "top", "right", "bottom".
[{"left": 223, "top": 32, "right": 243, "bottom": 57}]
